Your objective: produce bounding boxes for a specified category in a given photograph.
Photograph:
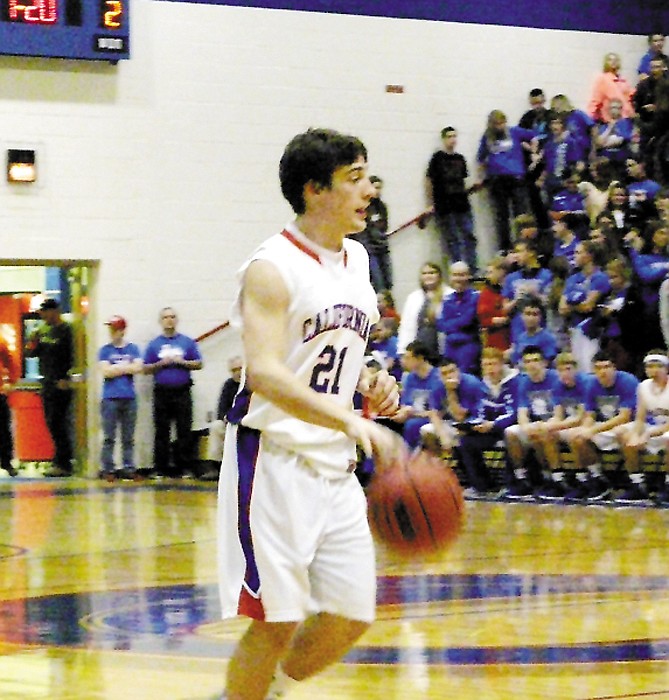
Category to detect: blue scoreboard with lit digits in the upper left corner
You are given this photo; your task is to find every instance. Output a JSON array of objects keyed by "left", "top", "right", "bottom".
[{"left": 0, "top": 0, "right": 130, "bottom": 62}]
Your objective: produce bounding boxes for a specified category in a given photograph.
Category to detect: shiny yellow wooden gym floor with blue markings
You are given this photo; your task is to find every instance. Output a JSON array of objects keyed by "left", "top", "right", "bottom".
[{"left": 0, "top": 479, "right": 669, "bottom": 700}]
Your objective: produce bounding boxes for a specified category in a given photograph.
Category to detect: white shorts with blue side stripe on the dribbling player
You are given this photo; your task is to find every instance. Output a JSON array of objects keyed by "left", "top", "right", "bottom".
[{"left": 219, "top": 426, "right": 376, "bottom": 622}]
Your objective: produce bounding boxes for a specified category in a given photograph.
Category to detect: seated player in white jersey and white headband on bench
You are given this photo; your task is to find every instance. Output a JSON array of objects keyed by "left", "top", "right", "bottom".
[{"left": 616, "top": 350, "right": 669, "bottom": 502}]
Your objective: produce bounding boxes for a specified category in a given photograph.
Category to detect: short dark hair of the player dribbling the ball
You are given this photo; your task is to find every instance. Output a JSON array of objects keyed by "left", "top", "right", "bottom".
[{"left": 279, "top": 129, "right": 367, "bottom": 214}]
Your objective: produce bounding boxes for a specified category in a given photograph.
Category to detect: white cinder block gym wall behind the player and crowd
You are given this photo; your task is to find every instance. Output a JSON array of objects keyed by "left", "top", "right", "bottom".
[{"left": 0, "top": 0, "right": 646, "bottom": 472}]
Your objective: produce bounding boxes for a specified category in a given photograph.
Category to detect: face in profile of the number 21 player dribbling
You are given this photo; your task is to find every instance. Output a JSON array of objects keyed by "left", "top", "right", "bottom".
[{"left": 312, "top": 156, "right": 376, "bottom": 234}]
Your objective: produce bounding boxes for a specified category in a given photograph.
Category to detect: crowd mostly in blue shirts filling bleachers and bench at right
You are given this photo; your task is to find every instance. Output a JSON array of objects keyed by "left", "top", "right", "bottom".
[{"left": 370, "top": 34, "right": 669, "bottom": 505}]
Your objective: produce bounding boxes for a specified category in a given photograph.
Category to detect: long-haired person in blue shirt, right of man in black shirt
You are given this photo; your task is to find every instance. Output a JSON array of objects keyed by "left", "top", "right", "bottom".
[{"left": 476, "top": 109, "right": 538, "bottom": 251}]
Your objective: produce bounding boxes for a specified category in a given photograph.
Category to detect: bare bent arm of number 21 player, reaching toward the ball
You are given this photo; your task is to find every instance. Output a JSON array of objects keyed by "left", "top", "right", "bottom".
[{"left": 242, "top": 260, "right": 394, "bottom": 457}]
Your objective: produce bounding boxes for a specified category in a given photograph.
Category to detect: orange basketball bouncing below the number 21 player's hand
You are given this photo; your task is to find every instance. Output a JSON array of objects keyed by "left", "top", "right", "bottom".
[{"left": 367, "top": 450, "right": 465, "bottom": 556}]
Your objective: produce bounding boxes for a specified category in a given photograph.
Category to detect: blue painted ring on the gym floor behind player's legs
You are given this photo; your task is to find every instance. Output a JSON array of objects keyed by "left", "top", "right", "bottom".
[{"left": 7, "top": 574, "right": 669, "bottom": 666}]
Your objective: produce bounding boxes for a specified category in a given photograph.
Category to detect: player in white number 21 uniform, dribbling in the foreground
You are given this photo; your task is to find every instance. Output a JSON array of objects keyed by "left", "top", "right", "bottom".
[{"left": 218, "top": 129, "right": 399, "bottom": 700}]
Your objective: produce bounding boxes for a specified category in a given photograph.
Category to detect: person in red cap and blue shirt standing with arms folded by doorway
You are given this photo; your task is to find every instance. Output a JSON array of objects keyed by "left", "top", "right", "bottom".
[{"left": 98, "top": 316, "right": 143, "bottom": 481}]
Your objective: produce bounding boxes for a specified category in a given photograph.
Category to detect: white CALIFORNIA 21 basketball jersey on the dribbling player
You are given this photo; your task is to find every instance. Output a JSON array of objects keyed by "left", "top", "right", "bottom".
[{"left": 228, "top": 224, "right": 379, "bottom": 477}]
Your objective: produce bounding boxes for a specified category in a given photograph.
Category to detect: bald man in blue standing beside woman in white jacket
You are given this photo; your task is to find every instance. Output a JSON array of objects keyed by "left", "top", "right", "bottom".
[{"left": 437, "top": 262, "right": 481, "bottom": 374}]
